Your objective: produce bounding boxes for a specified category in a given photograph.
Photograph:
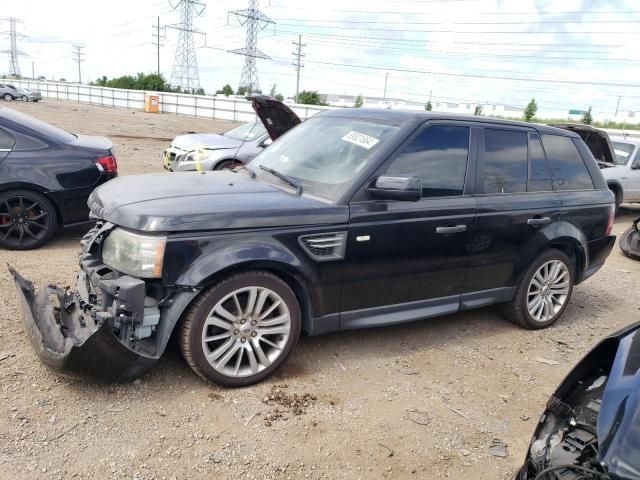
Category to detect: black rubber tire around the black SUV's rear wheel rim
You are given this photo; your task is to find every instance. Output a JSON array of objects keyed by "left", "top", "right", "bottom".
[{"left": 497, "top": 249, "right": 575, "bottom": 330}]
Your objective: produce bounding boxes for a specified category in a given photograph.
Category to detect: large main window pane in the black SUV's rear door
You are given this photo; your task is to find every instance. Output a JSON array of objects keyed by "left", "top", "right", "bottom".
[{"left": 481, "top": 128, "right": 528, "bottom": 193}]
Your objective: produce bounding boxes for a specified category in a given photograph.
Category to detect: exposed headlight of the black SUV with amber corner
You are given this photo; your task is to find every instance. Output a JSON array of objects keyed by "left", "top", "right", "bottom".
[{"left": 102, "top": 228, "right": 167, "bottom": 278}]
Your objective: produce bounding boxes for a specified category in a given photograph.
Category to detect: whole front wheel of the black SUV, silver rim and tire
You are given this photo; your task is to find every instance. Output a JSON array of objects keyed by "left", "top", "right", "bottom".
[{"left": 180, "top": 271, "right": 301, "bottom": 387}]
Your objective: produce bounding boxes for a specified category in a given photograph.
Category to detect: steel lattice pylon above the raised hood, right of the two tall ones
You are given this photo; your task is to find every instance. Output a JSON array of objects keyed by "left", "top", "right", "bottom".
[{"left": 229, "top": 0, "right": 275, "bottom": 93}]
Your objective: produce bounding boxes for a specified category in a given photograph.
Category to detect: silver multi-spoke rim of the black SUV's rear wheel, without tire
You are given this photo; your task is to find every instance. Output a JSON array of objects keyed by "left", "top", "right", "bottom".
[{"left": 527, "top": 260, "right": 571, "bottom": 322}]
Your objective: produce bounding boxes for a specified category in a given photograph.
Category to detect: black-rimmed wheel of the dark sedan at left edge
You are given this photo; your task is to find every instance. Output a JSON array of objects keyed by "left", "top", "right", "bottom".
[{"left": 0, "top": 190, "right": 58, "bottom": 250}]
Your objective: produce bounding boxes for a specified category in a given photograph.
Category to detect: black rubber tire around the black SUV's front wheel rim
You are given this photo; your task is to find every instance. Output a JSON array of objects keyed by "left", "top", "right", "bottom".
[{"left": 180, "top": 271, "right": 302, "bottom": 387}]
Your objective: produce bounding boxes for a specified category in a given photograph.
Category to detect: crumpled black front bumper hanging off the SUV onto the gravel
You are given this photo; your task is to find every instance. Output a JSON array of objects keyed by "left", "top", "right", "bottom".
[{"left": 9, "top": 267, "right": 158, "bottom": 382}]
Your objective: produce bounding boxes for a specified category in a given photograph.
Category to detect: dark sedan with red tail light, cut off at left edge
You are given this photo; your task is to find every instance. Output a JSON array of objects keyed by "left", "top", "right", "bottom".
[{"left": 0, "top": 107, "right": 117, "bottom": 250}]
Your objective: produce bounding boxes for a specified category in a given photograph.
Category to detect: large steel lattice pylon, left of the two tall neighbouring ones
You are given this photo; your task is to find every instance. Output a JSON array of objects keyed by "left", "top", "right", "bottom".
[{"left": 167, "top": 0, "right": 206, "bottom": 92}]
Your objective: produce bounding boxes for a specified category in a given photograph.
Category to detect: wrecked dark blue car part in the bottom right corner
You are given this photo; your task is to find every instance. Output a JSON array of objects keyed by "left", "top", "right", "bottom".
[{"left": 514, "top": 324, "right": 640, "bottom": 480}]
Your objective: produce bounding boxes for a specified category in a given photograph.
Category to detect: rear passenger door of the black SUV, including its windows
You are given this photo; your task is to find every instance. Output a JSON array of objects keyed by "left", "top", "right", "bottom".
[{"left": 462, "top": 125, "right": 560, "bottom": 300}]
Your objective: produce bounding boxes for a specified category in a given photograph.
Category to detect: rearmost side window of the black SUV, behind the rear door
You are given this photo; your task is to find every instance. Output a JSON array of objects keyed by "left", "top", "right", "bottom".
[{"left": 542, "top": 135, "right": 593, "bottom": 190}]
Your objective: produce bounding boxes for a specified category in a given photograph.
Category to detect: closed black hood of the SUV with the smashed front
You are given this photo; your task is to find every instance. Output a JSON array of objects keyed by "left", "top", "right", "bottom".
[{"left": 88, "top": 171, "right": 348, "bottom": 232}]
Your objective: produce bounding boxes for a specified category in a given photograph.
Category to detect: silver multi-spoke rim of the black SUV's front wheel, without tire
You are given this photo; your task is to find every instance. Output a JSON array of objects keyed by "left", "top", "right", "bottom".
[{"left": 202, "top": 287, "right": 291, "bottom": 377}]
